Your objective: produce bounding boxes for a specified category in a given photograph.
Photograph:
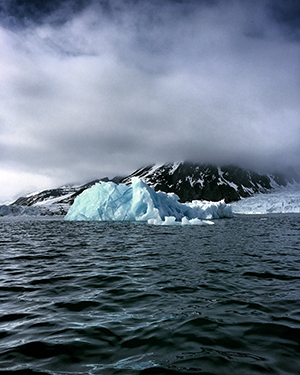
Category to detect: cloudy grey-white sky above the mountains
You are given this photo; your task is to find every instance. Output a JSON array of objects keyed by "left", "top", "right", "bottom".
[{"left": 0, "top": 0, "right": 300, "bottom": 203}]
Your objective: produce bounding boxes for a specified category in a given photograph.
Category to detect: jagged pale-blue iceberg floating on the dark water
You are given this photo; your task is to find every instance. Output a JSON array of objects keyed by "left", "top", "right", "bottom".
[{"left": 65, "top": 177, "right": 234, "bottom": 225}]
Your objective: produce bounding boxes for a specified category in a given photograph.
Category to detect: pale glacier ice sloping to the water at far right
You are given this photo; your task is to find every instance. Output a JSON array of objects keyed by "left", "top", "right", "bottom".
[{"left": 231, "top": 184, "right": 300, "bottom": 214}]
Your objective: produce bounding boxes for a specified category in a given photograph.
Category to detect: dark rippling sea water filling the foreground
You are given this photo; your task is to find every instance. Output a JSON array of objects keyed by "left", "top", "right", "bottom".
[{"left": 0, "top": 214, "right": 300, "bottom": 375}]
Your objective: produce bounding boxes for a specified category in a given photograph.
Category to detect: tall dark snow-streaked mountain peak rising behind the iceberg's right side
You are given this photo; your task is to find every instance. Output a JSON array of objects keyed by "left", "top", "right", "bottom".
[{"left": 121, "top": 162, "right": 299, "bottom": 203}]
